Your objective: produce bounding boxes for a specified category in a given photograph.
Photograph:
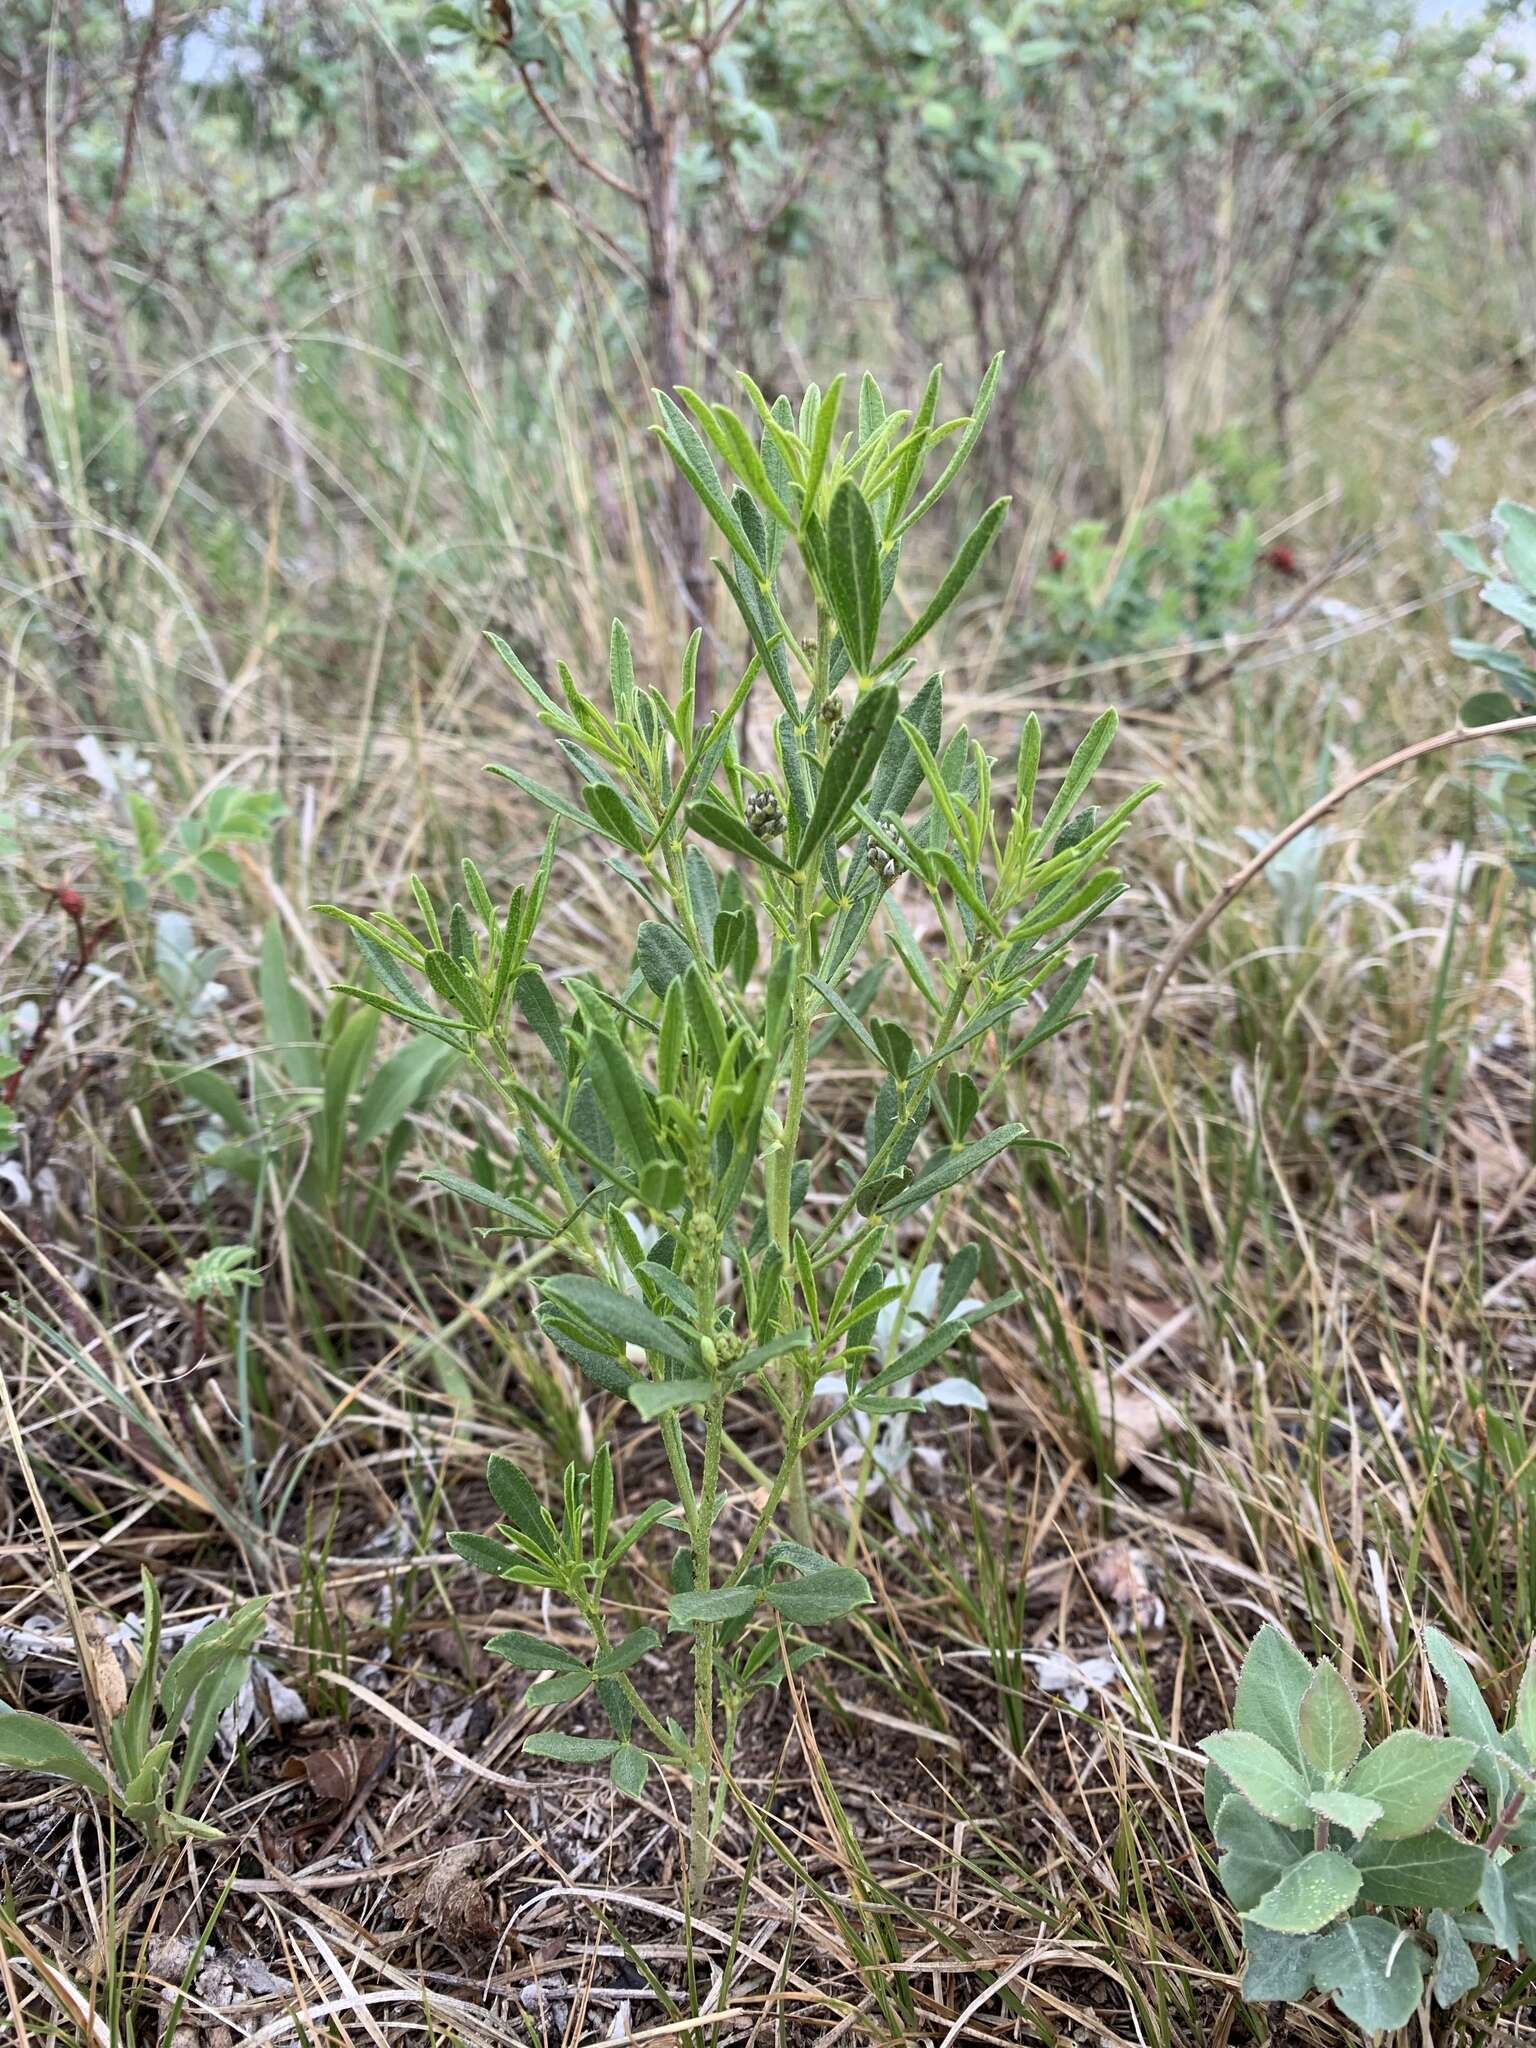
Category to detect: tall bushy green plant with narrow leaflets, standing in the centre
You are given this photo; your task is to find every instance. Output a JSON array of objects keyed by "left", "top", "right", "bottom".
[{"left": 319, "top": 365, "right": 1145, "bottom": 1882}]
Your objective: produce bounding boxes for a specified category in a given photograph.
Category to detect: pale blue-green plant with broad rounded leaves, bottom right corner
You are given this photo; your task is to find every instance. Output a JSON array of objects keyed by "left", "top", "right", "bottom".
[{"left": 1200, "top": 1626, "right": 1536, "bottom": 2034}]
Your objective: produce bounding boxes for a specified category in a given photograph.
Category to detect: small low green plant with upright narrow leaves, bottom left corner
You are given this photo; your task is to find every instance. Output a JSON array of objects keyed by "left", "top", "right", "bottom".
[{"left": 0, "top": 1571, "right": 268, "bottom": 1847}]
